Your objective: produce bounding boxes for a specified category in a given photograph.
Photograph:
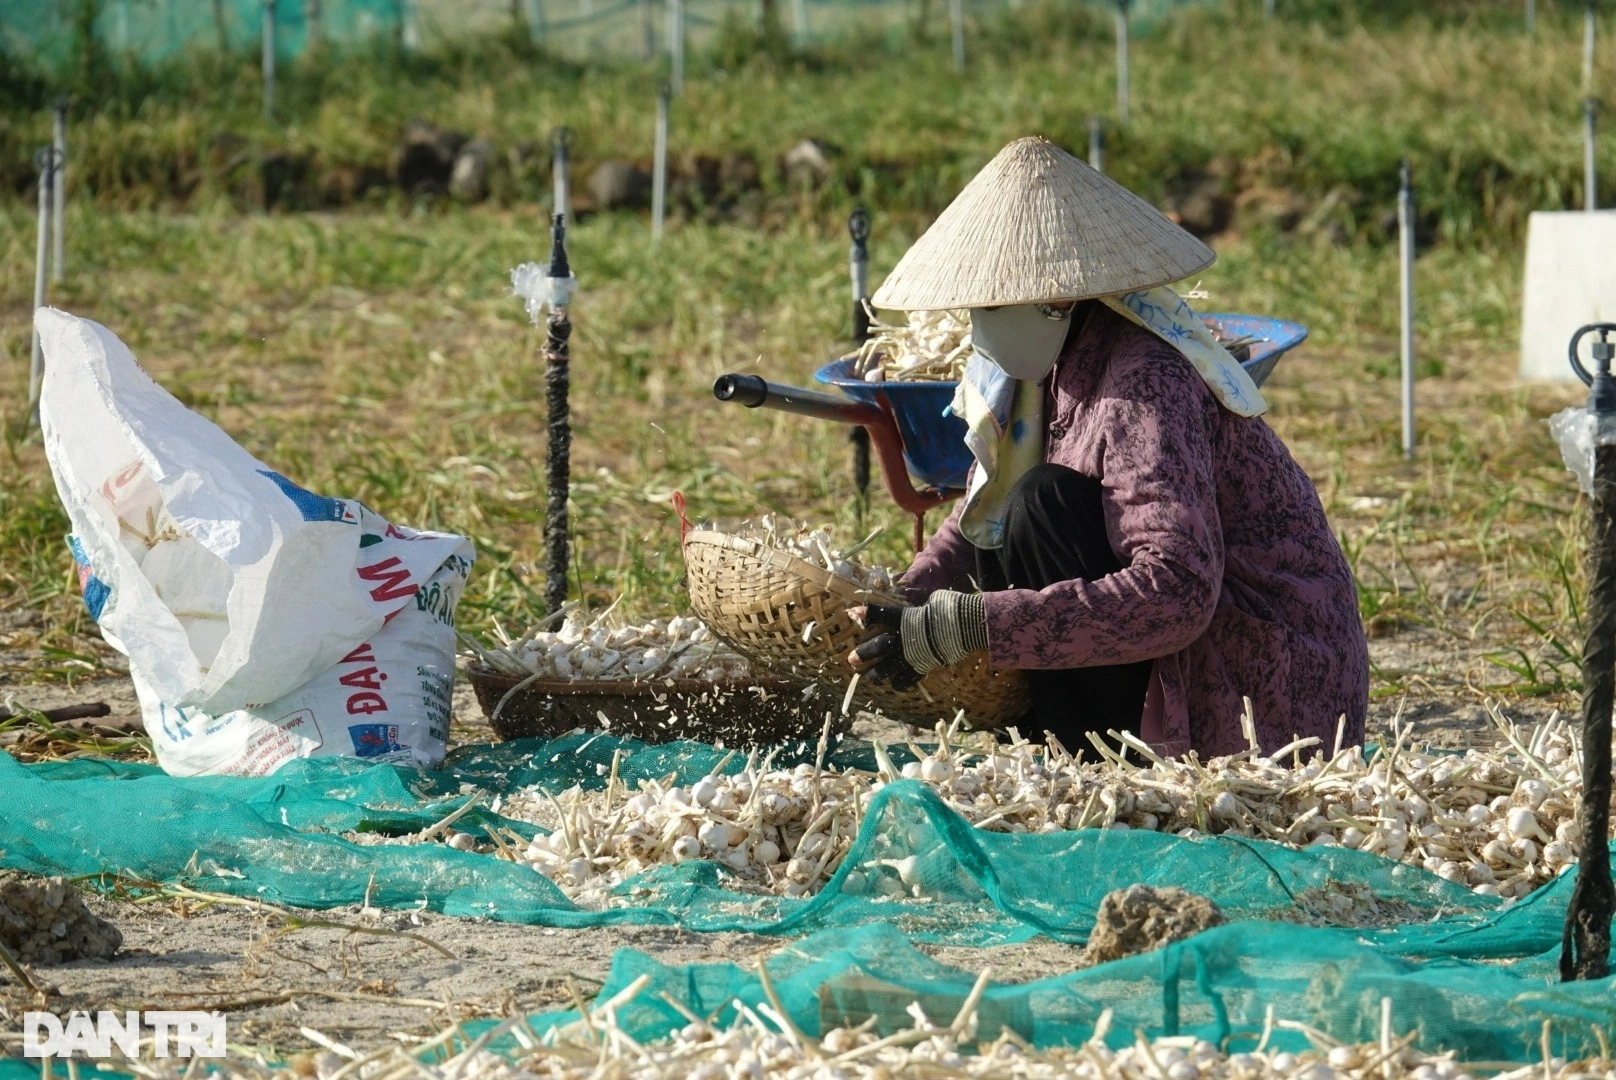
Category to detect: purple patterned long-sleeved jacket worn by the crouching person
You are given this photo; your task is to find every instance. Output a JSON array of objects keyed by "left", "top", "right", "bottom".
[{"left": 903, "top": 309, "right": 1369, "bottom": 757}]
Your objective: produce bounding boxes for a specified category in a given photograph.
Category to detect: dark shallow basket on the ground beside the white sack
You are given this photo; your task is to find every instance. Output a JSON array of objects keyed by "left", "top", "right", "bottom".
[{"left": 465, "top": 664, "right": 820, "bottom": 747}]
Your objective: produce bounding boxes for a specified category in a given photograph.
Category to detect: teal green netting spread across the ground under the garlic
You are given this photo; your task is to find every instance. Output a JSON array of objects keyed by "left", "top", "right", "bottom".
[{"left": 0, "top": 734, "right": 1616, "bottom": 1061}]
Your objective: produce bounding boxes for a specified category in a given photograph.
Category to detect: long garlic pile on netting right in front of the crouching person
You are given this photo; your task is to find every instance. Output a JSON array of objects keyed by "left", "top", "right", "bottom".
[{"left": 446, "top": 704, "right": 1580, "bottom": 905}]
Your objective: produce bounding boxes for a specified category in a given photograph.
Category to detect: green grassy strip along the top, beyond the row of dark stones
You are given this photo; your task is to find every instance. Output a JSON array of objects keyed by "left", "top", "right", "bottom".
[{"left": 0, "top": 0, "right": 1616, "bottom": 246}]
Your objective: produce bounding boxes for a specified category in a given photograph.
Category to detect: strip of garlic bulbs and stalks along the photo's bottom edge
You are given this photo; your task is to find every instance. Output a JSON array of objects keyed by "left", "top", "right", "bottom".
[{"left": 154, "top": 989, "right": 1577, "bottom": 1080}]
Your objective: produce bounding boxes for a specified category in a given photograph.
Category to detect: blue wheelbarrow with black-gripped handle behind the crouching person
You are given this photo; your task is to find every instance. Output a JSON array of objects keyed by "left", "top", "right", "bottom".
[{"left": 713, "top": 314, "right": 1307, "bottom": 551}]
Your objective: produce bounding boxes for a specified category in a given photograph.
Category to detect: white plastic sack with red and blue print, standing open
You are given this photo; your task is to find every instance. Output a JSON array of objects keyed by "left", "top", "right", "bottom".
[{"left": 36, "top": 310, "right": 475, "bottom": 774}]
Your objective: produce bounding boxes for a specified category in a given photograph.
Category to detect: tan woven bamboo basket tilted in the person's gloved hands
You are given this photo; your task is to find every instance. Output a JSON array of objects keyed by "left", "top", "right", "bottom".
[{"left": 685, "top": 529, "right": 1028, "bottom": 728}]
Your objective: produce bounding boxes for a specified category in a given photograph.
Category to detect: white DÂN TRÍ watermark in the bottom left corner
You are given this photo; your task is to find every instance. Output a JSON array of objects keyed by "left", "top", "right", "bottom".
[{"left": 23, "top": 1010, "right": 225, "bottom": 1057}]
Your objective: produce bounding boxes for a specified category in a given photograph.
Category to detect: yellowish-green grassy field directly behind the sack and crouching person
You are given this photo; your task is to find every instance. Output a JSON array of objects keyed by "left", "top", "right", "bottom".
[{"left": 0, "top": 210, "right": 1580, "bottom": 721}]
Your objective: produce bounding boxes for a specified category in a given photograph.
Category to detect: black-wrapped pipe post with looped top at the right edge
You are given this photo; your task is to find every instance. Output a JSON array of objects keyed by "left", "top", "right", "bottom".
[{"left": 1559, "top": 323, "right": 1616, "bottom": 981}]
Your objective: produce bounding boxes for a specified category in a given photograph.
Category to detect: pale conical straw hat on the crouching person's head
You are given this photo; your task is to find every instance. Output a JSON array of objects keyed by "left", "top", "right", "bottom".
[{"left": 873, "top": 137, "right": 1217, "bottom": 310}]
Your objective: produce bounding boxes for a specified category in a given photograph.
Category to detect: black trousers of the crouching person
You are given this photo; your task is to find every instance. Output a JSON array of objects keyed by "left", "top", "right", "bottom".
[{"left": 976, "top": 464, "right": 1154, "bottom": 752}]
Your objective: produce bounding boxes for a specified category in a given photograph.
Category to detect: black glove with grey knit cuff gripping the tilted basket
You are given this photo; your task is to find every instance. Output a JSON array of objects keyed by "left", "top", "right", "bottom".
[{"left": 853, "top": 589, "right": 987, "bottom": 690}]
